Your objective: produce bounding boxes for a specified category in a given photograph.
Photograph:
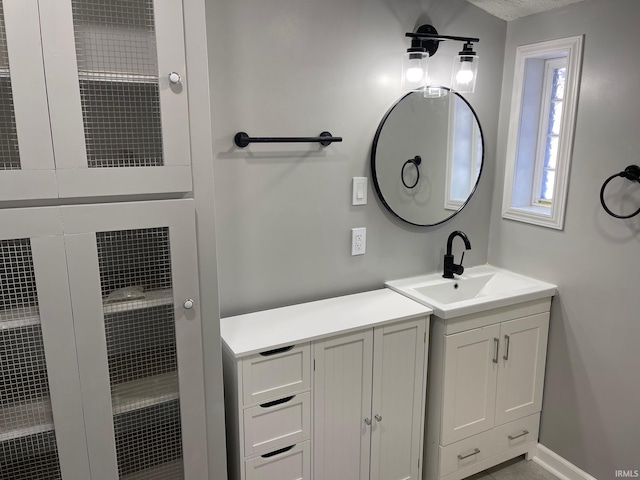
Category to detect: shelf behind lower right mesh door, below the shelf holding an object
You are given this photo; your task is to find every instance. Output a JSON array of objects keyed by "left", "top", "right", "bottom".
[{"left": 111, "top": 372, "right": 180, "bottom": 415}]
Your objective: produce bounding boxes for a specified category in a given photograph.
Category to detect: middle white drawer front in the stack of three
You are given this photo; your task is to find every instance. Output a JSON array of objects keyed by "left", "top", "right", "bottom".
[{"left": 244, "top": 392, "right": 311, "bottom": 457}]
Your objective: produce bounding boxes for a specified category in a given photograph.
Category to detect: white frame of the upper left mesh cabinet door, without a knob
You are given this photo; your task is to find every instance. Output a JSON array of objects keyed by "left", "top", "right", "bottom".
[{"left": 0, "top": 0, "right": 57, "bottom": 201}]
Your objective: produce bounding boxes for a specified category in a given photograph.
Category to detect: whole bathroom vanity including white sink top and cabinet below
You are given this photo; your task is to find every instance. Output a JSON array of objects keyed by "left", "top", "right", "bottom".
[{"left": 387, "top": 265, "right": 556, "bottom": 480}]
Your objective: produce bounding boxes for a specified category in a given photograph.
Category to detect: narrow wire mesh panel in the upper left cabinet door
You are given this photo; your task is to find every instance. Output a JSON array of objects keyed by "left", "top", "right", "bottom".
[{"left": 0, "top": 0, "right": 20, "bottom": 170}]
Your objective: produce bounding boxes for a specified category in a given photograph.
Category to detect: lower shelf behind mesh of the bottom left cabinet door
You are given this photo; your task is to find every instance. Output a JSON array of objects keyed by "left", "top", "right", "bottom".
[{"left": 0, "top": 397, "right": 53, "bottom": 442}]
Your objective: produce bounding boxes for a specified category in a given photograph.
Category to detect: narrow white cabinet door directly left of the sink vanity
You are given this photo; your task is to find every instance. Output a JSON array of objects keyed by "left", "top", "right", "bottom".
[{"left": 371, "top": 320, "right": 426, "bottom": 480}]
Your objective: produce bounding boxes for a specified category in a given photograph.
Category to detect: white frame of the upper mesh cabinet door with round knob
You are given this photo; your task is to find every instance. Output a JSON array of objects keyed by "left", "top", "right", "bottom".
[{"left": 37, "top": 0, "right": 192, "bottom": 198}]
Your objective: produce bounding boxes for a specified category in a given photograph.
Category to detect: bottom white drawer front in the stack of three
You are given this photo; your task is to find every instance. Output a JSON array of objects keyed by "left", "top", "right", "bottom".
[{"left": 245, "top": 440, "right": 311, "bottom": 480}]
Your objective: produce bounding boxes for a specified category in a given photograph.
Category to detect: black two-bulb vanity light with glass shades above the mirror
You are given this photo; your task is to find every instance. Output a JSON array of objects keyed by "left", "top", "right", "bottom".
[{"left": 402, "top": 25, "right": 480, "bottom": 96}]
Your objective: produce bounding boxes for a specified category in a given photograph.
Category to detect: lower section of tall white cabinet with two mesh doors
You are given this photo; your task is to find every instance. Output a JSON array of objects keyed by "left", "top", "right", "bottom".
[{"left": 0, "top": 200, "right": 207, "bottom": 480}]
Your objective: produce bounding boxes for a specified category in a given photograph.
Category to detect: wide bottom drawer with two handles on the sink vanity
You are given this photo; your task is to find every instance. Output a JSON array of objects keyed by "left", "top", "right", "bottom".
[{"left": 440, "top": 413, "right": 540, "bottom": 477}]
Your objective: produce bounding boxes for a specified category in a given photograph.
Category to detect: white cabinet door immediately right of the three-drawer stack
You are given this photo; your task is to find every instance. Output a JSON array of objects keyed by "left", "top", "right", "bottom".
[{"left": 313, "top": 330, "right": 373, "bottom": 480}]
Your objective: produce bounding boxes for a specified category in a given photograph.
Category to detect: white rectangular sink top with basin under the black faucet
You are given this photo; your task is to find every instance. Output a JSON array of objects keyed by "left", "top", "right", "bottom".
[{"left": 385, "top": 265, "right": 557, "bottom": 319}]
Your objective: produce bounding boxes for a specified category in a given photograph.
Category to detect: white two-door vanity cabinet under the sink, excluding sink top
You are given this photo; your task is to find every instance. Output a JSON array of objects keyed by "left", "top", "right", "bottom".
[{"left": 425, "top": 298, "right": 551, "bottom": 480}]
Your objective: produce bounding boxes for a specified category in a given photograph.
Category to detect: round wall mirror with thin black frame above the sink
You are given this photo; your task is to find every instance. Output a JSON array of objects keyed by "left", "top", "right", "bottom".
[{"left": 371, "top": 88, "right": 484, "bottom": 227}]
